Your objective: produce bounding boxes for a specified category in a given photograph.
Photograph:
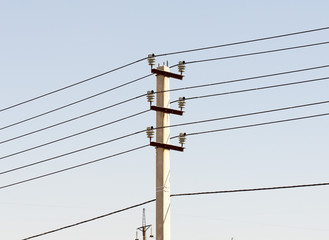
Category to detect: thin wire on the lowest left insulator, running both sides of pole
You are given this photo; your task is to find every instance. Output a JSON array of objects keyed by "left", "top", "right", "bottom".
[{"left": 0, "top": 100, "right": 329, "bottom": 175}]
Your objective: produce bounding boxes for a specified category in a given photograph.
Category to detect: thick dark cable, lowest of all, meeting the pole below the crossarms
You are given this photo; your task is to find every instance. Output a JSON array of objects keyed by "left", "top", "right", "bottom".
[{"left": 22, "top": 182, "right": 329, "bottom": 240}]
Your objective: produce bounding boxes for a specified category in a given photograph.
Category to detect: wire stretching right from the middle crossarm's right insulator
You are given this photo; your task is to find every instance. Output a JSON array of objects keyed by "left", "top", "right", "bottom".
[{"left": 170, "top": 77, "right": 329, "bottom": 103}]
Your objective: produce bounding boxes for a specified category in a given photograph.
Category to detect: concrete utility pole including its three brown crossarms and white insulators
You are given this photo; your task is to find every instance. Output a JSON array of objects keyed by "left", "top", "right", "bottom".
[{"left": 148, "top": 56, "right": 185, "bottom": 240}]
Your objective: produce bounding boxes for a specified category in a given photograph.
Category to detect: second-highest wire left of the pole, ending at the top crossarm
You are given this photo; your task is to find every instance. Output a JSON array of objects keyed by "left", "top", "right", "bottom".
[{"left": 0, "top": 73, "right": 153, "bottom": 130}]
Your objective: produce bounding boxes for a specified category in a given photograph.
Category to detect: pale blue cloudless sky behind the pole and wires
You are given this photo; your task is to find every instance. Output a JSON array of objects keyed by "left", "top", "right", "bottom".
[{"left": 0, "top": 0, "right": 329, "bottom": 240}]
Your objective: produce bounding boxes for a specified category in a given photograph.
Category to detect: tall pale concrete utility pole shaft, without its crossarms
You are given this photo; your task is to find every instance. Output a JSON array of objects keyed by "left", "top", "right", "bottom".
[{"left": 156, "top": 66, "right": 170, "bottom": 240}]
